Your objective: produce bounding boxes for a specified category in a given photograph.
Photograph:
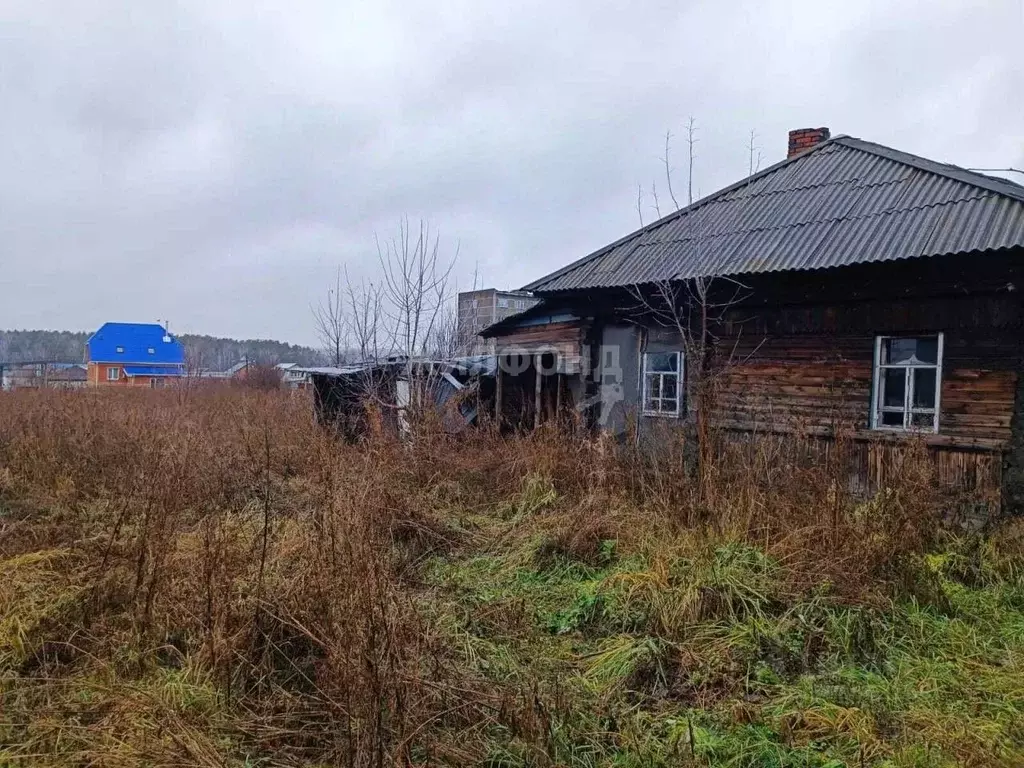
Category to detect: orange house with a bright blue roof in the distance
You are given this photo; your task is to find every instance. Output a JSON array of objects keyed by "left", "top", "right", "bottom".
[{"left": 86, "top": 323, "right": 185, "bottom": 387}]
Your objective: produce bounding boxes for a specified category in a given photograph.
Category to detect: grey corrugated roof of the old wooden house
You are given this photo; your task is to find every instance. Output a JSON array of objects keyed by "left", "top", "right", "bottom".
[{"left": 523, "top": 136, "right": 1024, "bottom": 294}]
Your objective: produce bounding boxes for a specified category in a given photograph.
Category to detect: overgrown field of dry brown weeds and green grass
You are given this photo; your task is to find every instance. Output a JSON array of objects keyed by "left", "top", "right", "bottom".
[{"left": 0, "top": 390, "right": 1024, "bottom": 766}]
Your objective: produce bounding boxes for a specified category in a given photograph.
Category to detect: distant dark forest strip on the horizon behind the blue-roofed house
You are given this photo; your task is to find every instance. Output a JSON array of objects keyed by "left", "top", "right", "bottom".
[{"left": 0, "top": 331, "right": 323, "bottom": 371}]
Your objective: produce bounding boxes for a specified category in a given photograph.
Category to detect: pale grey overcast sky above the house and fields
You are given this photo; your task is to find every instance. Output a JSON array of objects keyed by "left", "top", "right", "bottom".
[{"left": 0, "top": 0, "right": 1024, "bottom": 343}]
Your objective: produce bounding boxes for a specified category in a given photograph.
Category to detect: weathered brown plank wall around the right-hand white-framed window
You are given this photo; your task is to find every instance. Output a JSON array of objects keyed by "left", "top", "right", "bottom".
[{"left": 713, "top": 288, "right": 1021, "bottom": 501}]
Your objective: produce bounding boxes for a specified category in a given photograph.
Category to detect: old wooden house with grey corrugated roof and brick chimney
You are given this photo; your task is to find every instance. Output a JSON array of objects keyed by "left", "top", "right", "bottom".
[{"left": 483, "top": 128, "right": 1024, "bottom": 510}]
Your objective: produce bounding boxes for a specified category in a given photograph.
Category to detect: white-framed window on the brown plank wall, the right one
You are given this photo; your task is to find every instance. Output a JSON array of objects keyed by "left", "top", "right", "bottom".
[{"left": 873, "top": 334, "right": 942, "bottom": 432}]
